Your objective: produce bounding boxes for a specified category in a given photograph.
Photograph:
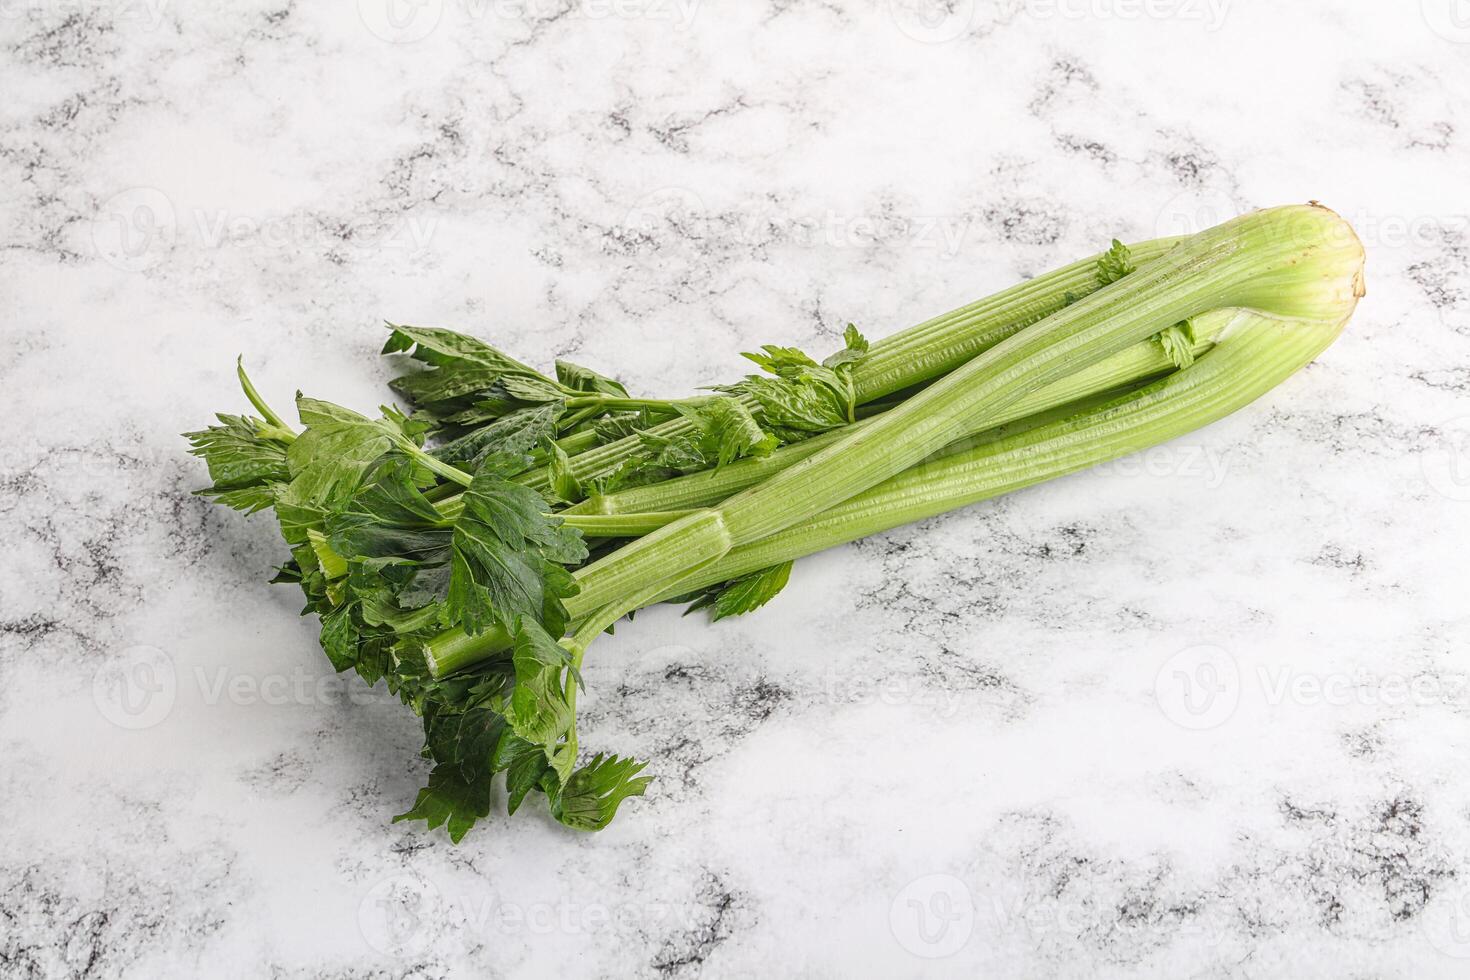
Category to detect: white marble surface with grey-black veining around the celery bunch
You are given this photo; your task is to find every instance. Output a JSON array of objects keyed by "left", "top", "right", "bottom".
[{"left": 0, "top": 0, "right": 1470, "bottom": 979}]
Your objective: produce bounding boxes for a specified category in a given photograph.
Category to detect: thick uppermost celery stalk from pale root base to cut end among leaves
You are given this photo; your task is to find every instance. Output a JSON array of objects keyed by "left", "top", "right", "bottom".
[{"left": 425, "top": 204, "right": 1363, "bottom": 673}]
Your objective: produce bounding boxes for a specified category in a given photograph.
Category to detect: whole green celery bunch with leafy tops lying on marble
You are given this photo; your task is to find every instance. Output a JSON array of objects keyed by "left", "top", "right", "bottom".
[{"left": 188, "top": 204, "right": 1363, "bottom": 840}]
